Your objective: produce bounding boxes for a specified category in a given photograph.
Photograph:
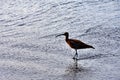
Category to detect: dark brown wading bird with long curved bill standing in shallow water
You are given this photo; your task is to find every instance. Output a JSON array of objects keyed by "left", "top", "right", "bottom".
[{"left": 56, "top": 32, "right": 95, "bottom": 59}]
